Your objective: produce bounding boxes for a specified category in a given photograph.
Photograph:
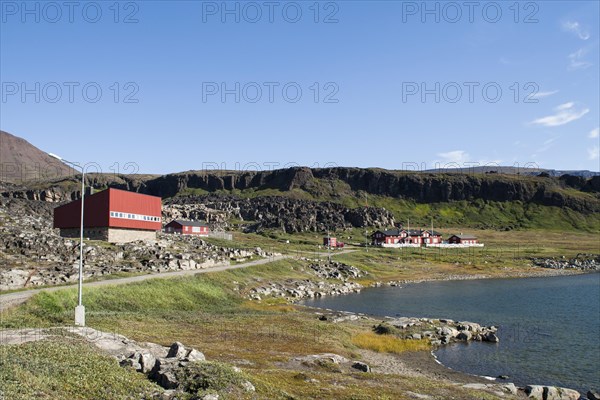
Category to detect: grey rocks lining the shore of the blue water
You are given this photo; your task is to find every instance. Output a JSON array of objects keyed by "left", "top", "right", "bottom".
[{"left": 247, "top": 262, "right": 597, "bottom": 400}]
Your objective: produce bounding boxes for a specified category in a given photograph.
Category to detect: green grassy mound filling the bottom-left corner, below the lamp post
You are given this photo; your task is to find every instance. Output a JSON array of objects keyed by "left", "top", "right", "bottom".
[{"left": 0, "top": 337, "right": 160, "bottom": 400}]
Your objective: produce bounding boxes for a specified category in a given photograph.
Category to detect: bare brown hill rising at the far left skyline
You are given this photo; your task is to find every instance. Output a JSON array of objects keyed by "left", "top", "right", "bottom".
[{"left": 0, "top": 131, "right": 77, "bottom": 183}]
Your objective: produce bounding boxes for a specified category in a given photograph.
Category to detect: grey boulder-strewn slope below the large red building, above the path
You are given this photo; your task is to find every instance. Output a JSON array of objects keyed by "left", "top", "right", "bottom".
[{"left": 0, "top": 198, "right": 271, "bottom": 290}]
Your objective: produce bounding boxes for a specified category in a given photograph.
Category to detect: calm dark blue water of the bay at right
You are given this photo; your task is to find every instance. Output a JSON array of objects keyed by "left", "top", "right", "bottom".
[{"left": 304, "top": 274, "right": 600, "bottom": 393}]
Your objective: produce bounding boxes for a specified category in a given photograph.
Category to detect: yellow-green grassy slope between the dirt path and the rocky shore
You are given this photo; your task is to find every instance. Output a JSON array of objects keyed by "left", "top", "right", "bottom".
[{"left": 0, "top": 254, "right": 524, "bottom": 399}]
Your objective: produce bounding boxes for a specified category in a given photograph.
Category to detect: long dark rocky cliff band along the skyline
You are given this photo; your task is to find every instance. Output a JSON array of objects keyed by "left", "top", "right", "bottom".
[{"left": 0, "top": 168, "right": 600, "bottom": 213}]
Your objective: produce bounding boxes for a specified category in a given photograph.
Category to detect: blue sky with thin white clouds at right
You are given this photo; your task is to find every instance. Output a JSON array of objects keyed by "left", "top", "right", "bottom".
[{"left": 0, "top": 0, "right": 600, "bottom": 173}]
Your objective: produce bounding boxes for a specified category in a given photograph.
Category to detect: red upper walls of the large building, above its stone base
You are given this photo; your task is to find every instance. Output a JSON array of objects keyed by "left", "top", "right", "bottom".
[{"left": 54, "top": 188, "right": 162, "bottom": 231}]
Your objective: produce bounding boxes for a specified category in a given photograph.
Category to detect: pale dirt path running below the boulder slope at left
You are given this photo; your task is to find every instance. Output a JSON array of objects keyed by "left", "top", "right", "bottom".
[{"left": 0, "top": 253, "right": 288, "bottom": 312}]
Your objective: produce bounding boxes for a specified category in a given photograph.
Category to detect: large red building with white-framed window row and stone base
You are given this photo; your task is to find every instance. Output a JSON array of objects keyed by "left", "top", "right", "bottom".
[{"left": 54, "top": 188, "right": 162, "bottom": 243}]
